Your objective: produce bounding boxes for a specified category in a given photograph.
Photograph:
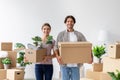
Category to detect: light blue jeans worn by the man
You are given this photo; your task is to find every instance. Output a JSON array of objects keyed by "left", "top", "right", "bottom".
[{"left": 60, "top": 66, "right": 80, "bottom": 80}]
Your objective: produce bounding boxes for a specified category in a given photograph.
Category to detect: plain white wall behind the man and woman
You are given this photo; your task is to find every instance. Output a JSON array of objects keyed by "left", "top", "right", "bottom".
[{"left": 0, "top": 0, "right": 120, "bottom": 77}]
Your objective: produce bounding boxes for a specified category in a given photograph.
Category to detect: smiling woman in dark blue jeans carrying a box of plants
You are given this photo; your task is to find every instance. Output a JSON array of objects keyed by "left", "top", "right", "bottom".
[{"left": 26, "top": 23, "right": 55, "bottom": 80}]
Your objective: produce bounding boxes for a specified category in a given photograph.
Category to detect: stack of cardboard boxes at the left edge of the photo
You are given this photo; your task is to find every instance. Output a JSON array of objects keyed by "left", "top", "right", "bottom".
[{"left": 0, "top": 42, "right": 24, "bottom": 80}]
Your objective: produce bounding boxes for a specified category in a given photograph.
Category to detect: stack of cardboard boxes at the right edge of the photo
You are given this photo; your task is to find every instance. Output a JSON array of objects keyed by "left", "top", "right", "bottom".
[{"left": 86, "top": 44, "right": 120, "bottom": 80}]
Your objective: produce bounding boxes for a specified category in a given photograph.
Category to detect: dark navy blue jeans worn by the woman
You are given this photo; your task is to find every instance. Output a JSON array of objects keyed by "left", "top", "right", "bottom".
[{"left": 35, "top": 64, "right": 53, "bottom": 80}]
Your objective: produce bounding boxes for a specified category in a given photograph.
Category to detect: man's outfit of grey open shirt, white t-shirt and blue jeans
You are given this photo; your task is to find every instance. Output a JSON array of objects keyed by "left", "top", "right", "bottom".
[{"left": 55, "top": 30, "right": 86, "bottom": 80}]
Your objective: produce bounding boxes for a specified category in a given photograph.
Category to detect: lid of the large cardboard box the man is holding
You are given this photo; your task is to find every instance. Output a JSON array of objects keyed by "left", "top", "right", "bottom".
[{"left": 58, "top": 42, "right": 92, "bottom": 48}]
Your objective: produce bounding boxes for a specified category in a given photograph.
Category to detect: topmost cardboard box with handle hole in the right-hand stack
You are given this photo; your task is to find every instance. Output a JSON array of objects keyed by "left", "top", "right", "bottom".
[{"left": 108, "top": 44, "right": 120, "bottom": 58}]
